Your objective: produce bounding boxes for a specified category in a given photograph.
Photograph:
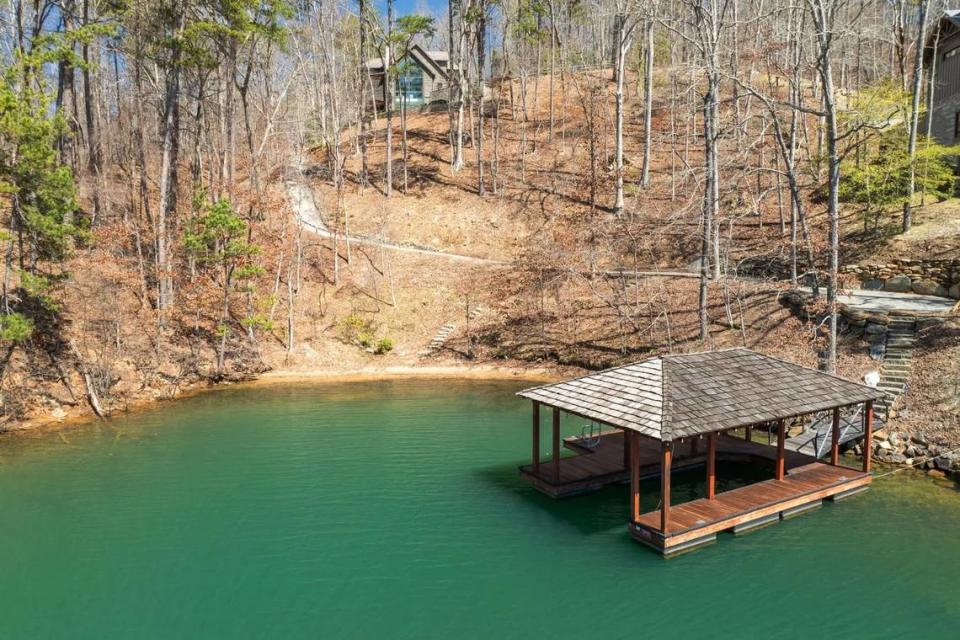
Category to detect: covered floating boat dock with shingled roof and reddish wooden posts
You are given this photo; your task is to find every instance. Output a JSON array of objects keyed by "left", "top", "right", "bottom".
[{"left": 519, "top": 349, "right": 883, "bottom": 556}]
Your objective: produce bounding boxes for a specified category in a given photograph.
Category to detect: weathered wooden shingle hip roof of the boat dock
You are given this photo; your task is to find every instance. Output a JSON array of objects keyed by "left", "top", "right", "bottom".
[{"left": 517, "top": 349, "right": 883, "bottom": 442}]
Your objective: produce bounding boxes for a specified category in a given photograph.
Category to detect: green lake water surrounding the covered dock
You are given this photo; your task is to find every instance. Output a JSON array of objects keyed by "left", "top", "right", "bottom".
[{"left": 0, "top": 380, "right": 960, "bottom": 640}]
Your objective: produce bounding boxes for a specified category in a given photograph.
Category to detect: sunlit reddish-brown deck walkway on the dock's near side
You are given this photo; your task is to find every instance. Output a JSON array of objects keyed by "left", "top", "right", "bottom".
[{"left": 630, "top": 462, "right": 871, "bottom": 556}]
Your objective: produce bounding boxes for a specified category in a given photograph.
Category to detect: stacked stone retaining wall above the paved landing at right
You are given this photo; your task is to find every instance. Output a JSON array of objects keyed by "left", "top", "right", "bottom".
[{"left": 840, "top": 258, "right": 960, "bottom": 299}]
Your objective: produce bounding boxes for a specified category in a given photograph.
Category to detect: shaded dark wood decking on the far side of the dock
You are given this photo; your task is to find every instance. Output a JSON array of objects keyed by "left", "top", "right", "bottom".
[{"left": 520, "top": 429, "right": 815, "bottom": 498}]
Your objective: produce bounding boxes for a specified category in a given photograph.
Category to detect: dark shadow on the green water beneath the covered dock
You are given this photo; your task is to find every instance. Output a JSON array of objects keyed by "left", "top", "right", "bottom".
[{"left": 475, "top": 461, "right": 773, "bottom": 536}]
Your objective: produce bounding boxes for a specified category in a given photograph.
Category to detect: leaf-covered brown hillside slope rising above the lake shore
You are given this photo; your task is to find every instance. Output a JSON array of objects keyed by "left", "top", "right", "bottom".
[{"left": 3, "top": 67, "right": 956, "bottom": 452}]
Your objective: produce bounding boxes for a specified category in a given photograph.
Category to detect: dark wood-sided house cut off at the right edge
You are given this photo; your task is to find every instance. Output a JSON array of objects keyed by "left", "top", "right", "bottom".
[{"left": 921, "top": 10, "right": 960, "bottom": 145}]
